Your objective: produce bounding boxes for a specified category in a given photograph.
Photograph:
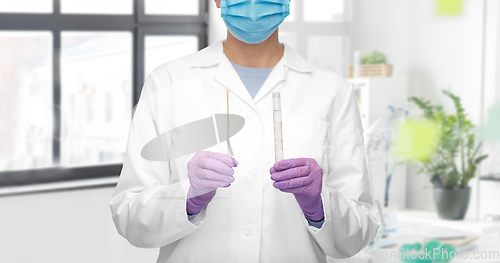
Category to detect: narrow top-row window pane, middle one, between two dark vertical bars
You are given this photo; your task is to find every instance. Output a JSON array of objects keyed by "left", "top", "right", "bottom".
[{"left": 61, "top": 0, "right": 133, "bottom": 15}]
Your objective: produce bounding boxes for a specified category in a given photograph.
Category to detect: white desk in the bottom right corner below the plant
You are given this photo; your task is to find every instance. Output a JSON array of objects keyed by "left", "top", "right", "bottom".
[{"left": 329, "top": 211, "right": 500, "bottom": 263}]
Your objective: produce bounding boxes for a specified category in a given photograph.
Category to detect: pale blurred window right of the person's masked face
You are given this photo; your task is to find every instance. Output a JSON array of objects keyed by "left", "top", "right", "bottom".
[{"left": 279, "top": 0, "right": 353, "bottom": 76}]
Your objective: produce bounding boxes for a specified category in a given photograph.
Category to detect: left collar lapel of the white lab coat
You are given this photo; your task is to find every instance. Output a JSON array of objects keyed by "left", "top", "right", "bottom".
[{"left": 214, "top": 53, "right": 256, "bottom": 110}]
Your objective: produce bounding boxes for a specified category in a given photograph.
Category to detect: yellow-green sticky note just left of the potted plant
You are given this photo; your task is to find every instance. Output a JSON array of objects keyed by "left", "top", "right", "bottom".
[{"left": 394, "top": 119, "right": 438, "bottom": 162}]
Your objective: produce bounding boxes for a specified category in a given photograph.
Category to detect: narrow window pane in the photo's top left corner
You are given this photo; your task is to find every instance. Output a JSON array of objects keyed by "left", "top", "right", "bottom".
[{"left": 0, "top": 0, "right": 53, "bottom": 13}]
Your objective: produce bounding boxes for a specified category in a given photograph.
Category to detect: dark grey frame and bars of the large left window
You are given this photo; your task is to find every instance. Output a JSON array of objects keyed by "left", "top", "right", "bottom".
[{"left": 0, "top": 0, "right": 208, "bottom": 196}]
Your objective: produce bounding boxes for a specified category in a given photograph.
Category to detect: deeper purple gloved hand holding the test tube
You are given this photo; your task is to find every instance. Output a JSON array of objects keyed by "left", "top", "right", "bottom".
[{"left": 270, "top": 158, "right": 324, "bottom": 222}]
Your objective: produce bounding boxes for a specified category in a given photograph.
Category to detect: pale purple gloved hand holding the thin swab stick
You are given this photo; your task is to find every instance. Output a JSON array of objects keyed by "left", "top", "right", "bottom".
[{"left": 186, "top": 151, "right": 238, "bottom": 215}]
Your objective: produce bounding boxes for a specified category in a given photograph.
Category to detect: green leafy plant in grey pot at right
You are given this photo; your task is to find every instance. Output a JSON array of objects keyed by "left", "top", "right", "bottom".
[{"left": 409, "top": 91, "right": 488, "bottom": 220}]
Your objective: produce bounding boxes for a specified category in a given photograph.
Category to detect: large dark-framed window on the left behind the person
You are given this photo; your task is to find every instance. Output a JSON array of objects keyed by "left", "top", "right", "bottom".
[{"left": 0, "top": 0, "right": 207, "bottom": 194}]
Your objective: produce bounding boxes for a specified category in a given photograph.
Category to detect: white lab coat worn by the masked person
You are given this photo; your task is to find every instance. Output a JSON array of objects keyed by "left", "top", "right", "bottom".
[{"left": 110, "top": 41, "right": 379, "bottom": 263}]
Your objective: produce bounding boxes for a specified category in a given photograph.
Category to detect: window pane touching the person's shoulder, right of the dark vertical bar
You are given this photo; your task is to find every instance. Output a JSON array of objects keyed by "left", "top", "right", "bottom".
[{"left": 144, "top": 36, "right": 198, "bottom": 76}]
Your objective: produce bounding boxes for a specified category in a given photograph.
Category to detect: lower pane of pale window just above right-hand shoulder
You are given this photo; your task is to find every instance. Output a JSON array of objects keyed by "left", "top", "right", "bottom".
[{"left": 307, "top": 36, "right": 349, "bottom": 76}]
